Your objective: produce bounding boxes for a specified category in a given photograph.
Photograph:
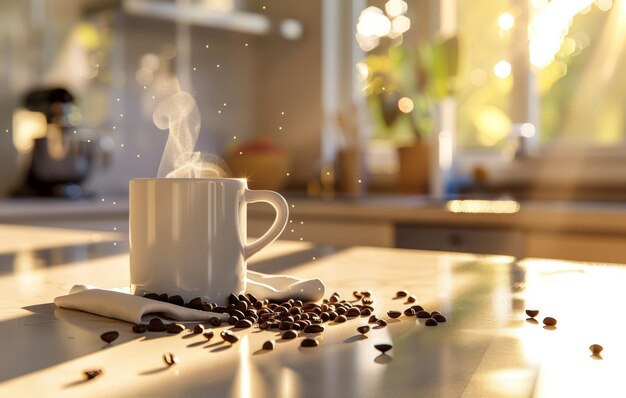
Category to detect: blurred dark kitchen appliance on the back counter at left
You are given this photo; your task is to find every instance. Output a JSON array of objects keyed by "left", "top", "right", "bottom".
[{"left": 13, "top": 88, "right": 110, "bottom": 198}]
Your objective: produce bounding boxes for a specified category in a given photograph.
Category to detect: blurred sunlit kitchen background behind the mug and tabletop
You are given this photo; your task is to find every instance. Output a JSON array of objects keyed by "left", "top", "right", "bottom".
[{"left": 0, "top": 0, "right": 626, "bottom": 262}]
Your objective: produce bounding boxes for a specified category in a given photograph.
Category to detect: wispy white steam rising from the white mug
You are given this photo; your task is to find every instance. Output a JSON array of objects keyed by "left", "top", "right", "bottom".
[{"left": 152, "top": 91, "right": 229, "bottom": 178}]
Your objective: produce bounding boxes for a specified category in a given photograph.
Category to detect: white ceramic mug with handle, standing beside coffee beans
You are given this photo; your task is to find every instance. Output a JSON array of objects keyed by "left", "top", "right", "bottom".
[{"left": 129, "top": 178, "right": 289, "bottom": 305}]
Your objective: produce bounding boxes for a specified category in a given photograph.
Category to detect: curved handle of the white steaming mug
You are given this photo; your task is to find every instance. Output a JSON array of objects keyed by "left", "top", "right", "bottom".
[{"left": 244, "top": 189, "right": 289, "bottom": 260}]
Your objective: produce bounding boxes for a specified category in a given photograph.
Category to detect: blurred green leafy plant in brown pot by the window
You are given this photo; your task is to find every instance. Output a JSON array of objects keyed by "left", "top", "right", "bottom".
[{"left": 364, "top": 37, "right": 458, "bottom": 193}]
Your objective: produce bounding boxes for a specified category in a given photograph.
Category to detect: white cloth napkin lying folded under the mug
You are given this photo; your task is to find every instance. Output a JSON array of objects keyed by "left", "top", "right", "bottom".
[{"left": 54, "top": 270, "right": 325, "bottom": 323}]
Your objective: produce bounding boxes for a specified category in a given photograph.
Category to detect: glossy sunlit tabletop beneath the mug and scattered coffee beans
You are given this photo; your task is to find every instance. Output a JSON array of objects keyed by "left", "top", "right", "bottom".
[{"left": 0, "top": 225, "right": 626, "bottom": 397}]
